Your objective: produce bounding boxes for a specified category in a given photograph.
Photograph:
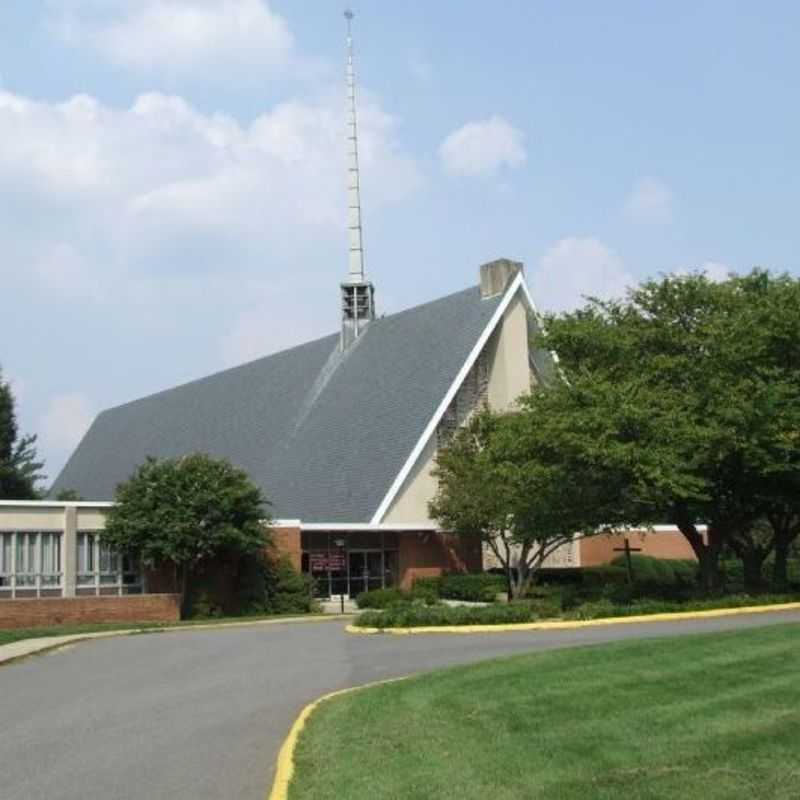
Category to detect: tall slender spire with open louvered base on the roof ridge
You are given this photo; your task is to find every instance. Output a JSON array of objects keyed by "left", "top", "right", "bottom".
[{"left": 341, "top": 9, "right": 375, "bottom": 349}]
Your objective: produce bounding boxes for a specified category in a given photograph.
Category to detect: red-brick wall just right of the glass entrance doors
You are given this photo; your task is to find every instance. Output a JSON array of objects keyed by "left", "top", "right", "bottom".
[{"left": 398, "top": 531, "right": 482, "bottom": 589}]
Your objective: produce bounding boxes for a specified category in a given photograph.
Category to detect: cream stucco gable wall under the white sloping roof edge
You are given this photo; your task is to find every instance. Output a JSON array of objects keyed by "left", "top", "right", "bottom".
[{"left": 383, "top": 290, "right": 531, "bottom": 524}]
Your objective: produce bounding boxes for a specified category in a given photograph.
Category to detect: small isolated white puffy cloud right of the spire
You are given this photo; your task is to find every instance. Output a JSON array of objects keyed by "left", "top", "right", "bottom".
[{"left": 439, "top": 116, "right": 528, "bottom": 175}]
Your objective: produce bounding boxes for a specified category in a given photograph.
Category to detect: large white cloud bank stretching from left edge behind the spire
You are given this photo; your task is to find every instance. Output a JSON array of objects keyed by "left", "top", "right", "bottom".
[{"left": 0, "top": 86, "right": 421, "bottom": 296}]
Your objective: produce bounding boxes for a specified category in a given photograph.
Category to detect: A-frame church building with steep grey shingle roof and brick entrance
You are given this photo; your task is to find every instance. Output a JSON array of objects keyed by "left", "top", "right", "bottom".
[{"left": 52, "top": 253, "right": 548, "bottom": 597}]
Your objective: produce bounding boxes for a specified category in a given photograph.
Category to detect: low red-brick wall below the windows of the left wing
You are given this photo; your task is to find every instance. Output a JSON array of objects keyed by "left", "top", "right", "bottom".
[{"left": 0, "top": 594, "right": 180, "bottom": 629}]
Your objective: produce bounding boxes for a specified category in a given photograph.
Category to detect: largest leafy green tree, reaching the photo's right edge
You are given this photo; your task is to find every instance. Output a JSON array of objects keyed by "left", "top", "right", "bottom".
[{"left": 546, "top": 270, "right": 800, "bottom": 589}]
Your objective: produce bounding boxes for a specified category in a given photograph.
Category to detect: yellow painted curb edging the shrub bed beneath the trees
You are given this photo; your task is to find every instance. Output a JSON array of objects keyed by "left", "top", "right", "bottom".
[{"left": 345, "top": 603, "right": 800, "bottom": 636}]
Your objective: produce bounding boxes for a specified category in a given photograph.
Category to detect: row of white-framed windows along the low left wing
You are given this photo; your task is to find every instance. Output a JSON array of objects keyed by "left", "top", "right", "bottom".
[{"left": 0, "top": 531, "right": 141, "bottom": 597}]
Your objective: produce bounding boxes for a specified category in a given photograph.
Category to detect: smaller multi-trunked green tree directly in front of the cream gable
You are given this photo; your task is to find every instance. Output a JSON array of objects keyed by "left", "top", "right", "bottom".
[{"left": 429, "top": 406, "right": 617, "bottom": 599}]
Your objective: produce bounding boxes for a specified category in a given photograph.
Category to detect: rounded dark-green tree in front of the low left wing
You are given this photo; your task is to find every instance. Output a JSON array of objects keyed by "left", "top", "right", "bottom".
[{"left": 103, "top": 453, "right": 270, "bottom": 602}]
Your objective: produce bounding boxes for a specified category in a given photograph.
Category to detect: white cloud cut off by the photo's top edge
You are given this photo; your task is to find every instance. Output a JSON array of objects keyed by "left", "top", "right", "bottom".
[{"left": 50, "top": 0, "right": 294, "bottom": 73}]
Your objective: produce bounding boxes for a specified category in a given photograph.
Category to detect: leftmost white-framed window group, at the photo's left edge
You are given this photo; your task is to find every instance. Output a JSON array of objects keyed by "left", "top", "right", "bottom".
[{"left": 0, "top": 531, "right": 62, "bottom": 597}]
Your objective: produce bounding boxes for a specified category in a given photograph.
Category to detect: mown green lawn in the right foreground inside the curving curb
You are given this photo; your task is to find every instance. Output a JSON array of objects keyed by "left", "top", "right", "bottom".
[{"left": 289, "top": 625, "right": 800, "bottom": 800}]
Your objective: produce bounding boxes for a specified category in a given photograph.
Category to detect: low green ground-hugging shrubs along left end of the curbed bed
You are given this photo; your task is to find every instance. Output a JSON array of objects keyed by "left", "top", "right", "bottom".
[{"left": 355, "top": 603, "right": 537, "bottom": 628}]
